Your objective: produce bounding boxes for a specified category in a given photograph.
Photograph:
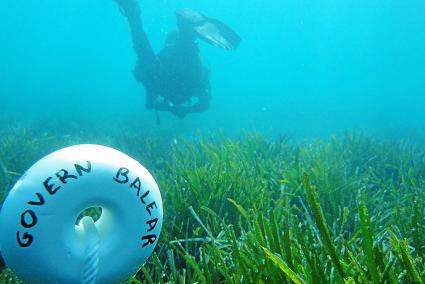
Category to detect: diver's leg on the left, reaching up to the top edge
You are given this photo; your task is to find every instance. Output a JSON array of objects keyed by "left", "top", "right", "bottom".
[{"left": 114, "top": 0, "right": 159, "bottom": 89}]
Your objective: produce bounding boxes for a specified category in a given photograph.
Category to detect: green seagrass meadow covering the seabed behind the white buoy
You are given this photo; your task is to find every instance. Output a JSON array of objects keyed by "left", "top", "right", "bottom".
[{"left": 0, "top": 121, "right": 425, "bottom": 283}]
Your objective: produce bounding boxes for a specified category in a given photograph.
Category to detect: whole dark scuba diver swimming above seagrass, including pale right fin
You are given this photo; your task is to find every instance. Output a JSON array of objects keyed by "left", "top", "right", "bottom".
[{"left": 114, "top": 0, "right": 240, "bottom": 118}]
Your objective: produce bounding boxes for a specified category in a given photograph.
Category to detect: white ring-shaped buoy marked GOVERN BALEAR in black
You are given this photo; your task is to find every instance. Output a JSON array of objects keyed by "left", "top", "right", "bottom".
[{"left": 0, "top": 144, "right": 163, "bottom": 283}]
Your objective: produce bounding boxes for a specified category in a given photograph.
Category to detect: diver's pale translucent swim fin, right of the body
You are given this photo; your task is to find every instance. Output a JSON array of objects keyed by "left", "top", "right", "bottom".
[{"left": 176, "top": 8, "right": 241, "bottom": 50}]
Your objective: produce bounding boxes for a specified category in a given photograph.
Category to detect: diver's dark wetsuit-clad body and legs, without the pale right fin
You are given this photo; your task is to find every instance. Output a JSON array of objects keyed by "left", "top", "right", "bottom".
[{"left": 115, "top": 0, "right": 211, "bottom": 117}]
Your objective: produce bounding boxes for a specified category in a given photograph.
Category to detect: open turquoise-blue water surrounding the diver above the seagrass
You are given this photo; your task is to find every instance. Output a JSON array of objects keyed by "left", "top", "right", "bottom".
[{"left": 0, "top": 0, "right": 425, "bottom": 137}]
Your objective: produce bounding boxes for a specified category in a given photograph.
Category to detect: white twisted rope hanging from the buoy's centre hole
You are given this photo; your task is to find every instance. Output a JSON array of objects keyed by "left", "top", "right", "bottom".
[{"left": 80, "top": 216, "right": 100, "bottom": 284}]
